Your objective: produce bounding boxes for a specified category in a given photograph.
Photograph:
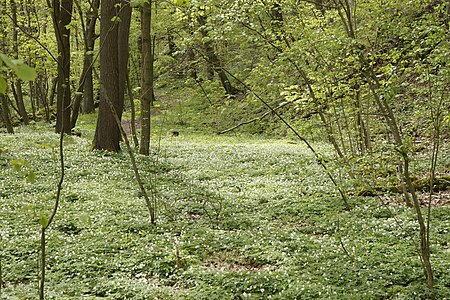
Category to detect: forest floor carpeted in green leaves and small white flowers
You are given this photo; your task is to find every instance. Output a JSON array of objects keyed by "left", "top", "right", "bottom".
[{"left": 0, "top": 90, "right": 450, "bottom": 300}]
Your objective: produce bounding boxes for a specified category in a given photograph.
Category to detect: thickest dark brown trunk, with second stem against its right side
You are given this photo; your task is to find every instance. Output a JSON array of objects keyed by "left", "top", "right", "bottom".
[{"left": 93, "top": 0, "right": 131, "bottom": 152}]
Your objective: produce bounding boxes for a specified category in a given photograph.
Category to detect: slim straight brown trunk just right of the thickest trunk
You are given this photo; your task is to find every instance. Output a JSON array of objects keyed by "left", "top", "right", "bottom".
[{"left": 139, "top": 2, "right": 153, "bottom": 155}]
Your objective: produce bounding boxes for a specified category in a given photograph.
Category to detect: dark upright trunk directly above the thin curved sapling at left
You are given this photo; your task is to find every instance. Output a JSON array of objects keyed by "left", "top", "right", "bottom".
[{"left": 52, "top": 0, "right": 73, "bottom": 134}]
